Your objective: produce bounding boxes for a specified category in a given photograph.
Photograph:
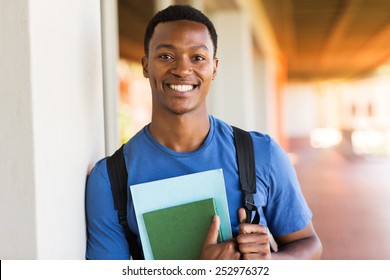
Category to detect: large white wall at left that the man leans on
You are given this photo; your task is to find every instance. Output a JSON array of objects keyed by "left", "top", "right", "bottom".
[{"left": 0, "top": 0, "right": 104, "bottom": 259}]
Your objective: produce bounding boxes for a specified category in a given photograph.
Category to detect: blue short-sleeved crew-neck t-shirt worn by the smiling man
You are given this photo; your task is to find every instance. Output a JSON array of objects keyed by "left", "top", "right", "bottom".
[{"left": 86, "top": 116, "right": 312, "bottom": 259}]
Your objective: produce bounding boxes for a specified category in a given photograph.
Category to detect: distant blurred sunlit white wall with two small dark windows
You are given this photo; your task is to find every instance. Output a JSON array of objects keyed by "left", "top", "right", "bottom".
[{"left": 284, "top": 75, "right": 390, "bottom": 137}]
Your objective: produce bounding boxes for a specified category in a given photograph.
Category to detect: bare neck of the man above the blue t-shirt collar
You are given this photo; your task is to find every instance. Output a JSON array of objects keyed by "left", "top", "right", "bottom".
[{"left": 149, "top": 112, "right": 210, "bottom": 152}]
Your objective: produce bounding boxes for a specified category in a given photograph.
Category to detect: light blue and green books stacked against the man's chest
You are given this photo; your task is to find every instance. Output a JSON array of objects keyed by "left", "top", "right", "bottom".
[{"left": 130, "top": 169, "right": 232, "bottom": 260}]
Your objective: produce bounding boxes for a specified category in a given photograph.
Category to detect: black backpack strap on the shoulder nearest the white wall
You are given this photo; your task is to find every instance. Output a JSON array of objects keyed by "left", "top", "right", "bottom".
[{"left": 107, "top": 145, "right": 144, "bottom": 260}]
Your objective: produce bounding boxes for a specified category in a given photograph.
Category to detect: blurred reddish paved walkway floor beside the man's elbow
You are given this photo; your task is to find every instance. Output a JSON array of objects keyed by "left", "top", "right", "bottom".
[{"left": 292, "top": 145, "right": 390, "bottom": 260}]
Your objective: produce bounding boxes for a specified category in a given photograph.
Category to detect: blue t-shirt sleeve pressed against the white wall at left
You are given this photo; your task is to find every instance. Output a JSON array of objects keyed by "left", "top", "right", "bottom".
[{"left": 86, "top": 159, "right": 130, "bottom": 260}]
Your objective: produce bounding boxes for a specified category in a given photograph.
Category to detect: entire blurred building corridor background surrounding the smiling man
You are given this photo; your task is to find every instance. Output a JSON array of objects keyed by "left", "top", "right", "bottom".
[{"left": 0, "top": 0, "right": 390, "bottom": 259}]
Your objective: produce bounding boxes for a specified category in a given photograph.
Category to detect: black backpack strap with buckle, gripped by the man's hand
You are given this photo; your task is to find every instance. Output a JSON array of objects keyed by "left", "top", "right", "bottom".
[{"left": 232, "top": 126, "right": 260, "bottom": 224}]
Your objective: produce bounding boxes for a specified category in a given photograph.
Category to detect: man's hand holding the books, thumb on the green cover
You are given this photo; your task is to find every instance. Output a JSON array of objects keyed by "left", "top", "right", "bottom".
[{"left": 200, "top": 216, "right": 241, "bottom": 260}]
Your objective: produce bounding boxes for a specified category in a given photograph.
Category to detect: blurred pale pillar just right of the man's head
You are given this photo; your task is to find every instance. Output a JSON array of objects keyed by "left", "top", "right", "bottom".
[{"left": 208, "top": 10, "right": 255, "bottom": 129}]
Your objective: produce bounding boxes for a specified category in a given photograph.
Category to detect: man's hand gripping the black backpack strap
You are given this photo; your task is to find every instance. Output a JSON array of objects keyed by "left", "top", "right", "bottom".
[{"left": 237, "top": 208, "right": 272, "bottom": 260}]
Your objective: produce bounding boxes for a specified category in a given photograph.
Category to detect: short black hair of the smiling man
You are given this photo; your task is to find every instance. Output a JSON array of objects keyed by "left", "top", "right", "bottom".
[{"left": 144, "top": 5, "right": 218, "bottom": 58}]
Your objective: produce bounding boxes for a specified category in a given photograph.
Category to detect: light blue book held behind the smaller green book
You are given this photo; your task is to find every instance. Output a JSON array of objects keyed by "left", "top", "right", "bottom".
[{"left": 130, "top": 169, "right": 232, "bottom": 260}]
